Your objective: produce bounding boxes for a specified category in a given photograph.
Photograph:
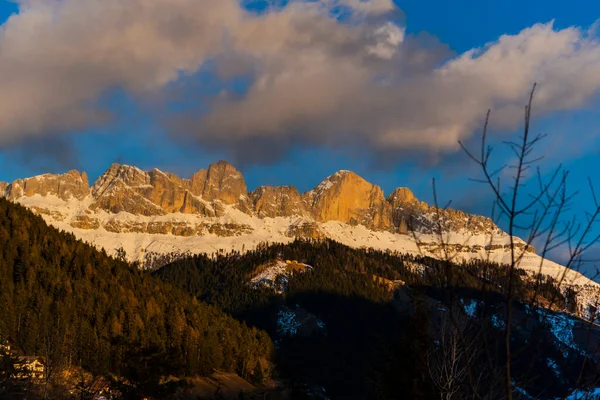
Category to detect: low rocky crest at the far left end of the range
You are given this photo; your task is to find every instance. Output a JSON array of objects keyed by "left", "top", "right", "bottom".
[{"left": 5, "top": 170, "right": 90, "bottom": 201}]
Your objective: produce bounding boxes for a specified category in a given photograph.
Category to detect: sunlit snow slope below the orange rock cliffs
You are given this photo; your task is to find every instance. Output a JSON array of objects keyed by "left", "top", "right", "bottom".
[{"left": 17, "top": 195, "right": 597, "bottom": 286}]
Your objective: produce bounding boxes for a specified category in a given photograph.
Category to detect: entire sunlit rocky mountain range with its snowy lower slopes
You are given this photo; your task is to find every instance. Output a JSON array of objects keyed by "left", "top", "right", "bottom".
[{"left": 0, "top": 161, "right": 598, "bottom": 306}]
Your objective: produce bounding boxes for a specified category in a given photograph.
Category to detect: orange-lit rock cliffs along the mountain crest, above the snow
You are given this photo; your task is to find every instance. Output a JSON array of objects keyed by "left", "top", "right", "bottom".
[{"left": 0, "top": 161, "right": 491, "bottom": 233}]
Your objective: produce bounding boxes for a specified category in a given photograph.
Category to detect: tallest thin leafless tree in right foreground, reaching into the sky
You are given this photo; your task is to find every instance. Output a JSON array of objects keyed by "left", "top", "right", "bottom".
[{"left": 460, "top": 85, "right": 600, "bottom": 399}]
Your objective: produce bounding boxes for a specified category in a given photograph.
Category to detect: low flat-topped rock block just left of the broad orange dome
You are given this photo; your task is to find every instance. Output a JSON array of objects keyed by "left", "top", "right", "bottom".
[{"left": 250, "top": 186, "right": 308, "bottom": 218}]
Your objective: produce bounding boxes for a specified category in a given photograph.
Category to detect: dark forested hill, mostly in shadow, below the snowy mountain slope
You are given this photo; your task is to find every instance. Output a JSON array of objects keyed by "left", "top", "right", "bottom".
[{"left": 154, "top": 241, "right": 600, "bottom": 399}]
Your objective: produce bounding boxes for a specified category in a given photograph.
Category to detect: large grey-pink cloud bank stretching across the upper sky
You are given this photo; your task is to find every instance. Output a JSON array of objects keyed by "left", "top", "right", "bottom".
[{"left": 0, "top": 0, "right": 600, "bottom": 161}]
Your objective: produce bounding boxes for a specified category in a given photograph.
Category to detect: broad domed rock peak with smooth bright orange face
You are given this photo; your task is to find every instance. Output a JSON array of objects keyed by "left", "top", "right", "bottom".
[{"left": 303, "top": 171, "right": 392, "bottom": 229}]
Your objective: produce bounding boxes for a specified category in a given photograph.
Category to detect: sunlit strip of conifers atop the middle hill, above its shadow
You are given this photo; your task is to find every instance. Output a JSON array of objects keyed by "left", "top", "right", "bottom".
[{"left": 154, "top": 240, "right": 565, "bottom": 317}]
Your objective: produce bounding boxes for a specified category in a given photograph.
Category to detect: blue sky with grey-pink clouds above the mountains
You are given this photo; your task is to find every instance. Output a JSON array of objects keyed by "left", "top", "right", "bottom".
[{"left": 0, "top": 0, "right": 600, "bottom": 272}]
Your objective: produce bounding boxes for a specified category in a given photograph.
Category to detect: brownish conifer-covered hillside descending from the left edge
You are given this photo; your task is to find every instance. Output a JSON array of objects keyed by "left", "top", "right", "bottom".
[{"left": 0, "top": 199, "right": 273, "bottom": 390}]
